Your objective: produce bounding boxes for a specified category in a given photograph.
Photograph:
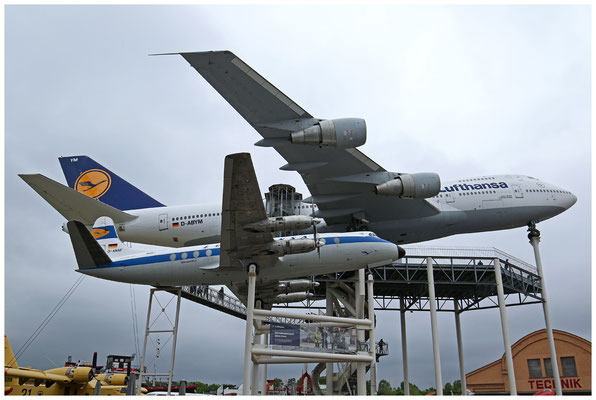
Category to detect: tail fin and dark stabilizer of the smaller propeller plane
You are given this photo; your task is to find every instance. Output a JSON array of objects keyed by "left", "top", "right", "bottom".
[{"left": 67, "top": 217, "right": 140, "bottom": 269}]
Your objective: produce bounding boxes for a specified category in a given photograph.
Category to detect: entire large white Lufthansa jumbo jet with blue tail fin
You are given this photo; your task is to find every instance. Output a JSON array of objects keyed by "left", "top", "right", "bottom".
[{"left": 21, "top": 51, "right": 577, "bottom": 247}]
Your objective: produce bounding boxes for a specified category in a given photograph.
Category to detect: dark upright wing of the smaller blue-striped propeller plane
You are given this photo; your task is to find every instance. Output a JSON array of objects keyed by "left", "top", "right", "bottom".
[{"left": 220, "top": 153, "right": 277, "bottom": 268}]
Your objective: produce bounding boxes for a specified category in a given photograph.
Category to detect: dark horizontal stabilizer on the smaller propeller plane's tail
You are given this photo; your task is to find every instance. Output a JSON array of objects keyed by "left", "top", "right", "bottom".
[{"left": 67, "top": 221, "right": 112, "bottom": 268}]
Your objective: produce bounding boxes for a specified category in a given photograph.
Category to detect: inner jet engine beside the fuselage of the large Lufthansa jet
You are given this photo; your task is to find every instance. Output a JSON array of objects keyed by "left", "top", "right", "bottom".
[{"left": 375, "top": 172, "right": 441, "bottom": 199}]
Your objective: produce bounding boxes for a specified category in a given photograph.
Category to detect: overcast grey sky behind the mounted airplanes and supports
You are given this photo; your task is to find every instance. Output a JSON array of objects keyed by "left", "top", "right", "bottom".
[{"left": 4, "top": 4, "right": 592, "bottom": 388}]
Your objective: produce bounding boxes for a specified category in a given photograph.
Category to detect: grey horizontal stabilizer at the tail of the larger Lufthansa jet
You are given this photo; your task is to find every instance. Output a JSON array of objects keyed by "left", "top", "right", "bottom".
[{"left": 19, "top": 174, "right": 137, "bottom": 225}]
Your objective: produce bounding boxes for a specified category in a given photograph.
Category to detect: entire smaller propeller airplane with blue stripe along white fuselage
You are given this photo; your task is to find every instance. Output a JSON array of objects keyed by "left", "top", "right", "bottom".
[{"left": 67, "top": 153, "right": 404, "bottom": 301}]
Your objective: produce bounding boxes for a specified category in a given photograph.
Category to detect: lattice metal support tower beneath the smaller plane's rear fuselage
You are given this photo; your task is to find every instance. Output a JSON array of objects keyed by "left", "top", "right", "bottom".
[{"left": 137, "top": 287, "right": 182, "bottom": 395}]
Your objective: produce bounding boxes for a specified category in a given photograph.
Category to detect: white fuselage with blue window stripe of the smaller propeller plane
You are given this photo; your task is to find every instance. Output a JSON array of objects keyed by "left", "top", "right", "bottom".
[{"left": 77, "top": 232, "right": 398, "bottom": 286}]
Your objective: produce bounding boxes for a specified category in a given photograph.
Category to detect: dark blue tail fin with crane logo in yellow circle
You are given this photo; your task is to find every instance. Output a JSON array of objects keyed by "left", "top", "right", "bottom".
[{"left": 58, "top": 156, "right": 164, "bottom": 210}]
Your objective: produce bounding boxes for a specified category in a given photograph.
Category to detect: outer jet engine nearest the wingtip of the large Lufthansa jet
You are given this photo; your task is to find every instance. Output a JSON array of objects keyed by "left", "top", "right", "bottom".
[{"left": 291, "top": 118, "right": 366, "bottom": 149}]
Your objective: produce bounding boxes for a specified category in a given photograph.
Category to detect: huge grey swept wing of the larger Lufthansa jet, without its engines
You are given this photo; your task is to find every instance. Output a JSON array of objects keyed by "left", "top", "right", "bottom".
[{"left": 179, "top": 51, "right": 440, "bottom": 225}]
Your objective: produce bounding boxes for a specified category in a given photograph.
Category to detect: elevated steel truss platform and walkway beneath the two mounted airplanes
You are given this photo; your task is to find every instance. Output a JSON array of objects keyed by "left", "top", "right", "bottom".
[{"left": 175, "top": 246, "right": 542, "bottom": 319}]
